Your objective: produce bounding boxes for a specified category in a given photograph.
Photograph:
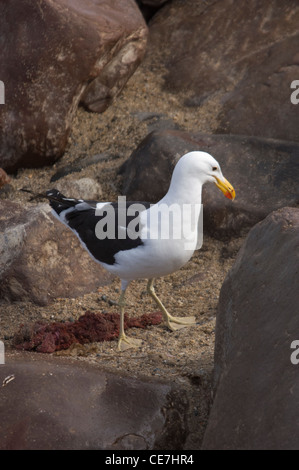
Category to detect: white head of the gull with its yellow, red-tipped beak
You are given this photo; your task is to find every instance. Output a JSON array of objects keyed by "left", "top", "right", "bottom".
[{"left": 173, "top": 151, "right": 236, "bottom": 200}]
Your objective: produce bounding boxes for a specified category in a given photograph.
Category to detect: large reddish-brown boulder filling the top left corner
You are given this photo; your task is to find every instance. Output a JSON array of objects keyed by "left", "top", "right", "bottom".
[{"left": 0, "top": 0, "right": 147, "bottom": 171}]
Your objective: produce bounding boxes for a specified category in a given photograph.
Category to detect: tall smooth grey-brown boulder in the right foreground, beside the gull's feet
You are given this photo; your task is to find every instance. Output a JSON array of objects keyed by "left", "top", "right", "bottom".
[{"left": 203, "top": 208, "right": 299, "bottom": 450}]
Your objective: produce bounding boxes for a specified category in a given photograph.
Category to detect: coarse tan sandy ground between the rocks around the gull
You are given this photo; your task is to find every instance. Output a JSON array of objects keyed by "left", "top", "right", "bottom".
[{"left": 0, "top": 55, "right": 242, "bottom": 449}]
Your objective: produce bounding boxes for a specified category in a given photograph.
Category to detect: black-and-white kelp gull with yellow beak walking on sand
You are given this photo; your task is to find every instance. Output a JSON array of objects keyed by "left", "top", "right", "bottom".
[{"left": 22, "top": 151, "right": 235, "bottom": 350}]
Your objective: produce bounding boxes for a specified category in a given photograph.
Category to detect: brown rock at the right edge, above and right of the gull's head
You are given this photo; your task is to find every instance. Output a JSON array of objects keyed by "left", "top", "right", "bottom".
[{"left": 217, "top": 35, "right": 299, "bottom": 142}]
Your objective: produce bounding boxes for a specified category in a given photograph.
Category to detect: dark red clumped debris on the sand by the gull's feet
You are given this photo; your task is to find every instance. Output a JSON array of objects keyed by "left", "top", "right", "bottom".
[{"left": 14, "top": 311, "right": 162, "bottom": 353}]
